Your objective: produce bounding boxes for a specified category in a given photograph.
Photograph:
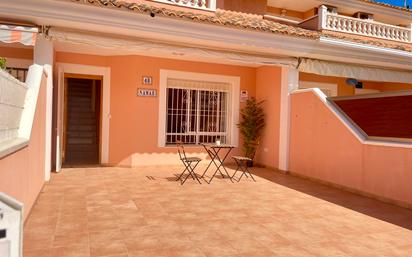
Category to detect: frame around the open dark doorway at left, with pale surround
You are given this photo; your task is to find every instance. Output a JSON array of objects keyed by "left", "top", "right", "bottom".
[{"left": 56, "top": 63, "right": 110, "bottom": 172}]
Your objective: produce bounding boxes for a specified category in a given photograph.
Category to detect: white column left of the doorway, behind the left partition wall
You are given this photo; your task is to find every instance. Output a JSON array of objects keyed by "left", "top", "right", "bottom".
[{"left": 34, "top": 35, "right": 54, "bottom": 181}]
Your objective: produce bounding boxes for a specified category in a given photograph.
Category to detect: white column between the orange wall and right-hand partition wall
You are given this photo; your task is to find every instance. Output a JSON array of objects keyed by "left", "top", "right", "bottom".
[{"left": 279, "top": 68, "right": 299, "bottom": 171}]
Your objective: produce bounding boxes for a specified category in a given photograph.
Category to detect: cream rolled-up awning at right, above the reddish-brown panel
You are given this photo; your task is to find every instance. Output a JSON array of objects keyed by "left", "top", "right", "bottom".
[{"left": 299, "top": 59, "right": 412, "bottom": 84}]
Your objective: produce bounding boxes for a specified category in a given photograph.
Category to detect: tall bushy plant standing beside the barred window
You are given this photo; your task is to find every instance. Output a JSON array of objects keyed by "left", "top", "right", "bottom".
[{"left": 238, "top": 97, "right": 265, "bottom": 167}]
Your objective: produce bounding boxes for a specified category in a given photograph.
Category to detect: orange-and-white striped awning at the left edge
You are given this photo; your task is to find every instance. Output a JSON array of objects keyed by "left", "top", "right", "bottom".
[{"left": 0, "top": 24, "right": 39, "bottom": 46}]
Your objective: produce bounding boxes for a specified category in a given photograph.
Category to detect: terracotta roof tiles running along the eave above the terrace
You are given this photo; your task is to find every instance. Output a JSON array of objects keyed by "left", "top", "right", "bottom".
[{"left": 66, "top": 0, "right": 412, "bottom": 52}]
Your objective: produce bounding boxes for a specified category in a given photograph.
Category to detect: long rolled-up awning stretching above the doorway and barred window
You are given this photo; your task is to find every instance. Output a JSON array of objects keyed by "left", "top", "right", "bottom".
[{"left": 48, "top": 27, "right": 298, "bottom": 67}]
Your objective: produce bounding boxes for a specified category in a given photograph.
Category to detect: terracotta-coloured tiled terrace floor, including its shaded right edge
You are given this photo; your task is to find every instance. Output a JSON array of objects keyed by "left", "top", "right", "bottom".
[{"left": 24, "top": 167, "right": 412, "bottom": 257}]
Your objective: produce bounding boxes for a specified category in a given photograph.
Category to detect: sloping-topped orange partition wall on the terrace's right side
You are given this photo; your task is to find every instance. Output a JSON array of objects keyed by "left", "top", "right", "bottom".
[{"left": 290, "top": 89, "right": 412, "bottom": 205}]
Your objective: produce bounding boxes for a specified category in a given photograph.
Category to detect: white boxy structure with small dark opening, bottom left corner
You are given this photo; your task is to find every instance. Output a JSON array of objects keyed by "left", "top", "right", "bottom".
[{"left": 0, "top": 193, "right": 23, "bottom": 257}]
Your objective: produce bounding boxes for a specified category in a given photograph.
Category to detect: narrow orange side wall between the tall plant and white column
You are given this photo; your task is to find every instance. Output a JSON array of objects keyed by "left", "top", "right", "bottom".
[{"left": 256, "top": 67, "right": 282, "bottom": 168}]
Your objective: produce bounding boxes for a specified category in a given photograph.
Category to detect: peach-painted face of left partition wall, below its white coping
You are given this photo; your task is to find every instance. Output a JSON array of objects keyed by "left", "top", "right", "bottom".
[{"left": 0, "top": 73, "right": 47, "bottom": 219}]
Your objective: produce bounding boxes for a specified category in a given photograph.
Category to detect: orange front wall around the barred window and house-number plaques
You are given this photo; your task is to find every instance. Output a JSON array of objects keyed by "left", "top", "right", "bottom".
[{"left": 56, "top": 52, "right": 262, "bottom": 166}]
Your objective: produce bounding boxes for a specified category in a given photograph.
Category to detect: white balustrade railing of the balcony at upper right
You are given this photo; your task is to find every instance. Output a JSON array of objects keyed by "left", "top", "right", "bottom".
[{"left": 319, "top": 6, "right": 412, "bottom": 43}]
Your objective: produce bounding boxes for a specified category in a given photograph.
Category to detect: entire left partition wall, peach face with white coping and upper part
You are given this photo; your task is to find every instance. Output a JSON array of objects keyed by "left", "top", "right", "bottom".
[{"left": 0, "top": 65, "right": 47, "bottom": 219}]
